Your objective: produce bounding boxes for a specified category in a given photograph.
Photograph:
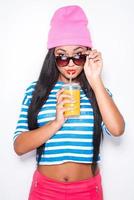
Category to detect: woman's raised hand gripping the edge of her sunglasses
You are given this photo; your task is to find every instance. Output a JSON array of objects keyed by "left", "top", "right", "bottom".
[{"left": 84, "top": 49, "right": 103, "bottom": 87}]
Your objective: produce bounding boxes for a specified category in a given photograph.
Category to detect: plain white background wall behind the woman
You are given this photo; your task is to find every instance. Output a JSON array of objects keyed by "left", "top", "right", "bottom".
[{"left": 0, "top": 0, "right": 134, "bottom": 200}]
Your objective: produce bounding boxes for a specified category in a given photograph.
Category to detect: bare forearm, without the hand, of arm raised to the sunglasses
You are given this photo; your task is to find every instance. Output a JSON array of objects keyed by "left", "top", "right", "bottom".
[{"left": 92, "top": 78, "right": 125, "bottom": 136}]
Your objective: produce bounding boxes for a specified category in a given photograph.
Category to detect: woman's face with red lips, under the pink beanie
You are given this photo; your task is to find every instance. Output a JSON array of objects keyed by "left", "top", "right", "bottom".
[{"left": 54, "top": 46, "right": 87, "bottom": 82}]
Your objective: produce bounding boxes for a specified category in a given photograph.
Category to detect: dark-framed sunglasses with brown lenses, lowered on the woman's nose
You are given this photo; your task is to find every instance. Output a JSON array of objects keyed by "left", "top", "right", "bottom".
[{"left": 55, "top": 54, "right": 87, "bottom": 67}]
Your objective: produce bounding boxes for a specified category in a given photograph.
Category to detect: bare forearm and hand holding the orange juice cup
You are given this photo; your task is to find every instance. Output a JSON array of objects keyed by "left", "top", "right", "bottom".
[{"left": 14, "top": 89, "right": 72, "bottom": 155}]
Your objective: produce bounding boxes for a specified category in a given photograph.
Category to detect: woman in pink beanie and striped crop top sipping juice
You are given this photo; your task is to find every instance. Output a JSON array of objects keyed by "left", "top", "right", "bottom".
[{"left": 14, "top": 6, "right": 125, "bottom": 200}]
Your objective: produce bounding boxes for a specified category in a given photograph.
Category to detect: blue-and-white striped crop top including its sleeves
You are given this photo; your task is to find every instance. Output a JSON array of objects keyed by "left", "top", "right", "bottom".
[{"left": 14, "top": 82, "right": 110, "bottom": 165}]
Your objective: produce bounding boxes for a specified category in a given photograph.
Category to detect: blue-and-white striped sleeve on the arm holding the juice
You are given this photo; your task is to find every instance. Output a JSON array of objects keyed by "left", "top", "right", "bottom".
[{"left": 13, "top": 82, "right": 36, "bottom": 141}]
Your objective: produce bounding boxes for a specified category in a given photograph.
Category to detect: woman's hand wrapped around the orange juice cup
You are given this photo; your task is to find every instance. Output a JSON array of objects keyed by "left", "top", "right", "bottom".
[{"left": 55, "top": 88, "right": 73, "bottom": 126}]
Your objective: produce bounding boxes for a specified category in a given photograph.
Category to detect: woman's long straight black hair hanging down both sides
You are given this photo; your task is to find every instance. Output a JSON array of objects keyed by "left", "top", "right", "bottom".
[{"left": 28, "top": 48, "right": 102, "bottom": 174}]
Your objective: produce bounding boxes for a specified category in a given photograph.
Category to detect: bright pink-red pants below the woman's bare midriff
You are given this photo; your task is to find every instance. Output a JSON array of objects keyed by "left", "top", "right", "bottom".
[{"left": 29, "top": 170, "right": 103, "bottom": 200}]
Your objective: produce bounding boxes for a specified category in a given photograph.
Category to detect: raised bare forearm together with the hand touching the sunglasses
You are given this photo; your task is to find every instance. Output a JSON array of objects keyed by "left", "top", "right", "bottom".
[{"left": 84, "top": 50, "right": 125, "bottom": 136}]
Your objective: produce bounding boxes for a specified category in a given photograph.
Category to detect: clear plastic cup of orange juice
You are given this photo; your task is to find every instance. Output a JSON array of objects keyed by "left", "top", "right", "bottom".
[{"left": 63, "top": 83, "right": 80, "bottom": 117}]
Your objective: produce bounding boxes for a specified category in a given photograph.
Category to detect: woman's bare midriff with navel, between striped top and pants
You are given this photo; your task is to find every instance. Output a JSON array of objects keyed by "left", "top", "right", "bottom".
[{"left": 37, "top": 162, "right": 98, "bottom": 182}]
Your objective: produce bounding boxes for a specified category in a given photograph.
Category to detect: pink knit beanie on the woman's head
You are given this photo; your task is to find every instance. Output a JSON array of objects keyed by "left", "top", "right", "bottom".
[{"left": 47, "top": 5, "right": 92, "bottom": 49}]
